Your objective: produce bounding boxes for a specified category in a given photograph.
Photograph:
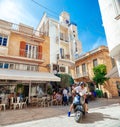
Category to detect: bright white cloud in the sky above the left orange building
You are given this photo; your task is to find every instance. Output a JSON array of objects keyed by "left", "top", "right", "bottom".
[{"left": 0, "top": 0, "right": 38, "bottom": 27}]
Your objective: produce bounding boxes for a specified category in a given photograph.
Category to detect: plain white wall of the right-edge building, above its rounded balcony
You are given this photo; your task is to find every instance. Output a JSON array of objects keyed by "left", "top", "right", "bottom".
[{"left": 99, "top": 0, "right": 120, "bottom": 55}]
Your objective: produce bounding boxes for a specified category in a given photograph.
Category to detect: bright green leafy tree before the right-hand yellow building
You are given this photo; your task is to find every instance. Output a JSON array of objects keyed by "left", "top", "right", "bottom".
[{"left": 93, "top": 64, "right": 109, "bottom": 87}]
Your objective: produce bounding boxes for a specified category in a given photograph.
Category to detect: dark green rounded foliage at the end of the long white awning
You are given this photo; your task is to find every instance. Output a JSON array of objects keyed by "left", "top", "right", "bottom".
[{"left": 56, "top": 74, "right": 74, "bottom": 87}]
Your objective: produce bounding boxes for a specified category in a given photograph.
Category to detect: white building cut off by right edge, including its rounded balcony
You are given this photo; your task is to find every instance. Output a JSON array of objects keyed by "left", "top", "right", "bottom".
[{"left": 99, "top": 0, "right": 120, "bottom": 77}]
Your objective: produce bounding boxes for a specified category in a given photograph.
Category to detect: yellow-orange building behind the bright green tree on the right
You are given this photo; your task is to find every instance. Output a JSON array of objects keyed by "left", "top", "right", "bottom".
[{"left": 74, "top": 46, "right": 120, "bottom": 97}]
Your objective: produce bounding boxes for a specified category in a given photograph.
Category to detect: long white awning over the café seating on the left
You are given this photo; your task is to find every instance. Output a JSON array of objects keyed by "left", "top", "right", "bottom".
[{"left": 0, "top": 69, "right": 61, "bottom": 81}]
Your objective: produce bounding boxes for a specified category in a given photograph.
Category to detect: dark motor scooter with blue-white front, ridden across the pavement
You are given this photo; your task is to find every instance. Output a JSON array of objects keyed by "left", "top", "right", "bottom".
[{"left": 73, "top": 93, "right": 85, "bottom": 123}]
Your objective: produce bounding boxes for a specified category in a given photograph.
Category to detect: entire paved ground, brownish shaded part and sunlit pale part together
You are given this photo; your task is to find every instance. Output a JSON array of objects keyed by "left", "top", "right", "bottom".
[{"left": 0, "top": 98, "right": 120, "bottom": 127}]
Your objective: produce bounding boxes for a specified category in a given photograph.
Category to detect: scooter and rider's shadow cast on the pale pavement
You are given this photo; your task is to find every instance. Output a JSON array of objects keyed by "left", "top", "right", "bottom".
[{"left": 79, "top": 112, "right": 119, "bottom": 124}]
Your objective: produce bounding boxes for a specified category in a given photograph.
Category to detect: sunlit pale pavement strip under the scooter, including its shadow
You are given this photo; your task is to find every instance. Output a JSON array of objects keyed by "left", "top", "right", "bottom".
[{"left": 2, "top": 104, "right": 120, "bottom": 127}]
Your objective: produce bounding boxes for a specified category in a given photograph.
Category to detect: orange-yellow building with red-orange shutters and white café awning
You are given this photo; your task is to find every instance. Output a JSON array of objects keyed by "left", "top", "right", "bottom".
[{"left": 0, "top": 20, "right": 60, "bottom": 100}]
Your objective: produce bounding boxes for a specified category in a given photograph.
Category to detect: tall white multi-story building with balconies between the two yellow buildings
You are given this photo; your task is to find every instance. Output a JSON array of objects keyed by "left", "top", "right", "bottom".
[{"left": 37, "top": 12, "right": 81, "bottom": 74}]
